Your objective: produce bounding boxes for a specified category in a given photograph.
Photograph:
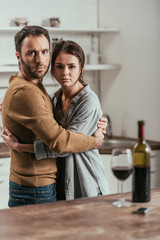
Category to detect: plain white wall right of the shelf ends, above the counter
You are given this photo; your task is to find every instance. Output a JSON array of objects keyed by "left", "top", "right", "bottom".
[{"left": 99, "top": 0, "right": 160, "bottom": 140}]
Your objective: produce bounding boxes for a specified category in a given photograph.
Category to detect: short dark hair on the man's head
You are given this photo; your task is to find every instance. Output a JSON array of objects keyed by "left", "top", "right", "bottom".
[{"left": 14, "top": 26, "right": 50, "bottom": 53}]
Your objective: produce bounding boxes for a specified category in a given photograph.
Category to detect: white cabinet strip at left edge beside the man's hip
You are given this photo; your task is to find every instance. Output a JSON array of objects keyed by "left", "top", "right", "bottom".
[{"left": 0, "top": 158, "right": 10, "bottom": 209}]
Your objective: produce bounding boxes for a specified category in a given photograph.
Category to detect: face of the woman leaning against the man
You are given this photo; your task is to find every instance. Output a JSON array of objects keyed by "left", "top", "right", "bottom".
[{"left": 53, "top": 52, "right": 81, "bottom": 89}]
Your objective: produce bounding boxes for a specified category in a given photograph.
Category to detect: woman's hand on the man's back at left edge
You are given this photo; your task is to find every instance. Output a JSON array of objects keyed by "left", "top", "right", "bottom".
[{"left": 1, "top": 128, "right": 19, "bottom": 151}]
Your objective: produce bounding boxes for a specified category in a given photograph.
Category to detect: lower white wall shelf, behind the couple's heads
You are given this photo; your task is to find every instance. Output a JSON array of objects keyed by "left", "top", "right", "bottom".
[{"left": 0, "top": 64, "right": 120, "bottom": 73}]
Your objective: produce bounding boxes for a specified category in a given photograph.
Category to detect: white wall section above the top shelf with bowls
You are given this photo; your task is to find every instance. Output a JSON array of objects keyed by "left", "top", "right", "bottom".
[{"left": 0, "top": 0, "right": 97, "bottom": 28}]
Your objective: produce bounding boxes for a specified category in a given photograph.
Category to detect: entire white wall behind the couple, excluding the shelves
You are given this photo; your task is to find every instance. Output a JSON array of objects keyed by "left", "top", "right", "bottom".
[{"left": 0, "top": 0, "right": 160, "bottom": 140}]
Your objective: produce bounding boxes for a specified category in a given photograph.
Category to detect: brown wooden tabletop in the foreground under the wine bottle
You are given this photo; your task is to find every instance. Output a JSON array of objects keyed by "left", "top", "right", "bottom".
[{"left": 0, "top": 189, "right": 160, "bottom": 240}]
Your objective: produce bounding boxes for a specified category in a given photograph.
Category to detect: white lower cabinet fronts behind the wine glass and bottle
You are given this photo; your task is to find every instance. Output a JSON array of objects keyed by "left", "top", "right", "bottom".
[{"left": 101, "top": 150, "right": 160, "bottom": 194}]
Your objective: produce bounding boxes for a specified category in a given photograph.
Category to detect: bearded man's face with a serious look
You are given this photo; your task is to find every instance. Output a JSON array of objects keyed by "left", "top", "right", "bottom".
[{"left": 16, "top": 35, "right": 50, "bottom": 80}]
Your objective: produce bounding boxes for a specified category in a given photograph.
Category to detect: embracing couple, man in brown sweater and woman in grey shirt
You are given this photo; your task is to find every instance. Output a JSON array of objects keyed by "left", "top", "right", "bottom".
[{"left": 1, "top": 26, "right": 109, "bottom": 207}]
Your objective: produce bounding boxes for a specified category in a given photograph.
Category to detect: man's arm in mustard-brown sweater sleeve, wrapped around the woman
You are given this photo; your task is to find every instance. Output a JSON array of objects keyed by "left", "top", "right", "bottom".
[{"left": 4, "top": 86, "right": 103, "bottom": 153}]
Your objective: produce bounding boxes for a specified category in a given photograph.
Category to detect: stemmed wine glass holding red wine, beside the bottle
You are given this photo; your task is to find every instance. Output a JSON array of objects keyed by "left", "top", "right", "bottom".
[{"left": 111, "top": 148, "right": 133, "bottom": 207}]
